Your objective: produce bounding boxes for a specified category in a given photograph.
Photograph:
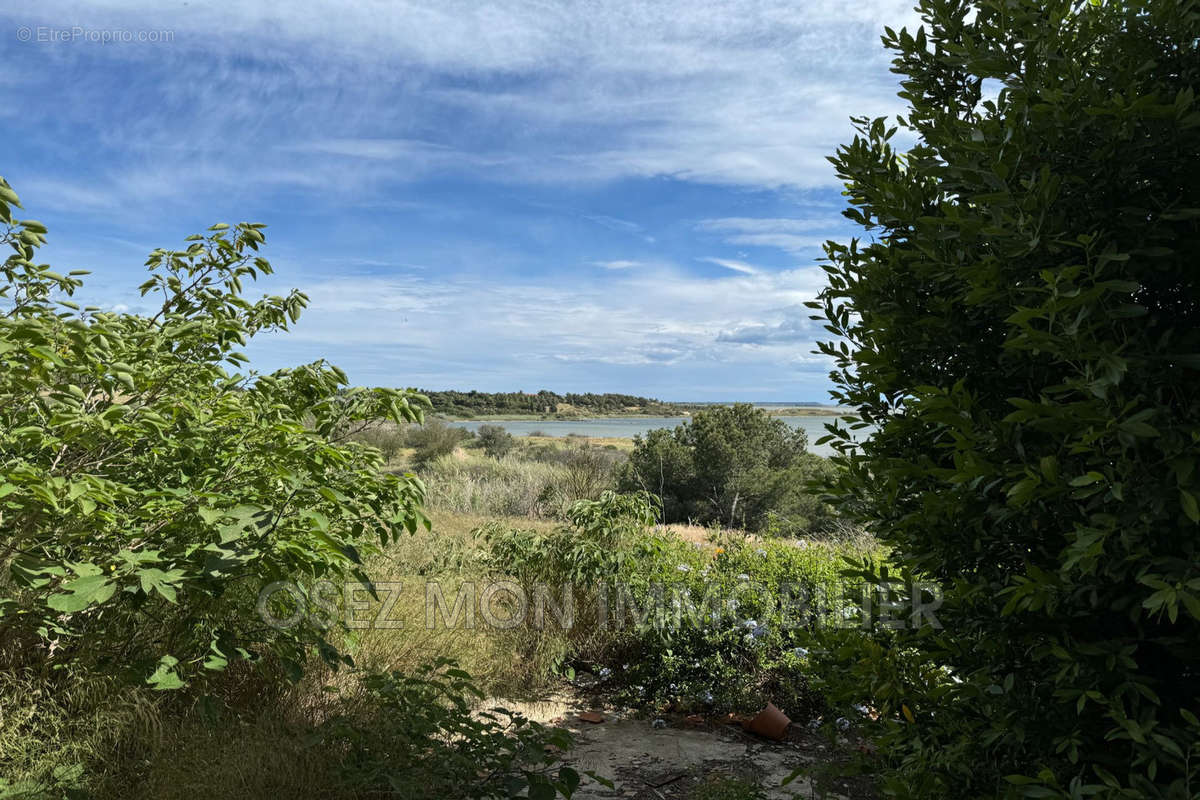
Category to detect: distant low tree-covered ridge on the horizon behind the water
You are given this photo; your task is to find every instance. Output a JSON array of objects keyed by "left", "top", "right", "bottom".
[{"left": 421, "top": 389, "right": 688, "bottom": 416}]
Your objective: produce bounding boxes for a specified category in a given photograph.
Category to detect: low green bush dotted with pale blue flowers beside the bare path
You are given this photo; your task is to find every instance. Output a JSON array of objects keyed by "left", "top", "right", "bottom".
[{"left": 600, "top": 534, "right": 860, "bottom": 723}]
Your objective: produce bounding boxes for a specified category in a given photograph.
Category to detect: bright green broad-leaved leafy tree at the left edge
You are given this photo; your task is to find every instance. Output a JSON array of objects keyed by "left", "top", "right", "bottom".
[{"left": 0, "top": 179, "right": 427, "bottom": 688}]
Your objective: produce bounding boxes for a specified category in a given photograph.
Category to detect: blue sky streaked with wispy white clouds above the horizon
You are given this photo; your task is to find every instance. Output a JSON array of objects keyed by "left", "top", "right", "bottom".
[{"left": 0, "top": 0, "right": 914, "bottom": 401}]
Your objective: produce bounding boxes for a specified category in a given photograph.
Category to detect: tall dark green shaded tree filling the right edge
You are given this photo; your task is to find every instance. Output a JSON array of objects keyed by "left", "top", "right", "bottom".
[{"left": 817, "top": 0, "right": 1200, "bottom": 798}]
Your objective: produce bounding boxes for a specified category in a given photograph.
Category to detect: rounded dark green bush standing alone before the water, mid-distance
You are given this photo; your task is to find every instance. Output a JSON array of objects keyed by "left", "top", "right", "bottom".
[{"left": 620, "top": 403, "right": 830, "bottom": 535}]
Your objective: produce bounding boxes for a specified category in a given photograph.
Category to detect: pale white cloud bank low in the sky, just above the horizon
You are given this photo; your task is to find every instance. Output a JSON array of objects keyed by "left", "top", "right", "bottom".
[{"left": 237, "top": 257, "right": 822, "bottom": 385}]
